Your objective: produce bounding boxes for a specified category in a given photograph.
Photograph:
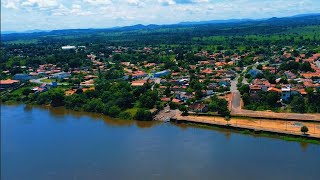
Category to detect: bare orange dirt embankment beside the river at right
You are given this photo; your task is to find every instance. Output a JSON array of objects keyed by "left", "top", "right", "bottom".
[{"left": 173, "top": 114, "right": 320, "bottom": 141}]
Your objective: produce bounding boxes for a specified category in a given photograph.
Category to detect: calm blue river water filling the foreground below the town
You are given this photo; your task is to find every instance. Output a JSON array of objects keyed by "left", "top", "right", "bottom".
[{"left": 1, "top": 105, "right": 320, "bottom": 180}]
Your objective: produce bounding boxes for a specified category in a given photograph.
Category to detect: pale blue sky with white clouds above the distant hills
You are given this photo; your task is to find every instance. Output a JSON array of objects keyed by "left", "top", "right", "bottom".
[{"left": 1, "top": 0, "right": 320, "bottom": 31}]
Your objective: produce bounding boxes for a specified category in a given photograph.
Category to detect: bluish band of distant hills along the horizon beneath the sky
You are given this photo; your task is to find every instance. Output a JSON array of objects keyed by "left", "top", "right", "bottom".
[{"left": 1, "top": 13, "right": 320, "bottom": 41}]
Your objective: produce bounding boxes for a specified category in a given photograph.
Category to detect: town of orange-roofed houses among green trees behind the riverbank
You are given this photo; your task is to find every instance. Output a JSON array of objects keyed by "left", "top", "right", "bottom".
[{"left": 0, "top": 43, "right": 320, "bottom": 121}]
